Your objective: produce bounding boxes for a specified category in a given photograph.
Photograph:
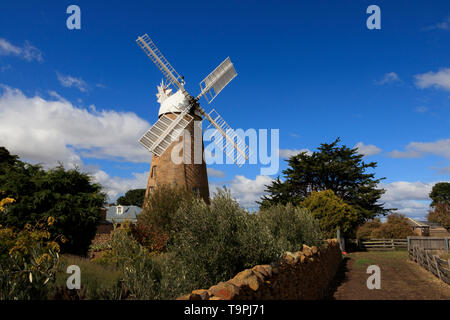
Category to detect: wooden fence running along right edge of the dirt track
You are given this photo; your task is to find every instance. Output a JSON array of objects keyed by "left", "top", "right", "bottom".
[{"left": 408, "top": 246, "right": 450, "bottom": 284}]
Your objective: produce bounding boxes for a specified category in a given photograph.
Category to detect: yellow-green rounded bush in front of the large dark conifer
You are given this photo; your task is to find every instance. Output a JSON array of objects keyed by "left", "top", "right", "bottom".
[{"left": 300, "top": 190, "right": 358, "bottom": 238}]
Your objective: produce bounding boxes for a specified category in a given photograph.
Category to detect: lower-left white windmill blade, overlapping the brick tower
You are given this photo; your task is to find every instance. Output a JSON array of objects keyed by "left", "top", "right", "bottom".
[{"left": 139, "top": 111, "right": 194, "bottom": 157}]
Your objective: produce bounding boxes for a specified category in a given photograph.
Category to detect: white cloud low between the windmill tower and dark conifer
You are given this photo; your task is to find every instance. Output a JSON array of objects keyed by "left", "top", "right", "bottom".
[{"left": 209, "top": 175, "right": 273, "bottom": 209}]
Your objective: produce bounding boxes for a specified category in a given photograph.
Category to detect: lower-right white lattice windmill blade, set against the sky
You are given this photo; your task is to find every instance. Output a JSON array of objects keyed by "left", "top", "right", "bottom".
[{"left": 204, "top": 109, "right": 250, "bottom": 167}]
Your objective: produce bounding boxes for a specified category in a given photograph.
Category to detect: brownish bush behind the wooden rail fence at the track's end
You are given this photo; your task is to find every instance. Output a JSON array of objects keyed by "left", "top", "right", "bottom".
[{"left": 357, "top": 213, "right": 414, "bottom": 239}]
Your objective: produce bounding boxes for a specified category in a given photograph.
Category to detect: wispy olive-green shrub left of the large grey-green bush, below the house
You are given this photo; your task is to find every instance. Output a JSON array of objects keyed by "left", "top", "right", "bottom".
[{"left": 97, "top": 225, "right": 162, "bottom": 299}]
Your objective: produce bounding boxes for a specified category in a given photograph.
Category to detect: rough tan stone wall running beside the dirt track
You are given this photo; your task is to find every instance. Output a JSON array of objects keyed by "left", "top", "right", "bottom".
[{"left": 177, "top": 239, "right": 342, "bottom": 300}]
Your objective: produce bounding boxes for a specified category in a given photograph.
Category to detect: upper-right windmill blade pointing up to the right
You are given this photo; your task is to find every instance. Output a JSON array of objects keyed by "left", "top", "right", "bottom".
[{"left": 197, "top": 57, "right": 237, "bottom": 103}]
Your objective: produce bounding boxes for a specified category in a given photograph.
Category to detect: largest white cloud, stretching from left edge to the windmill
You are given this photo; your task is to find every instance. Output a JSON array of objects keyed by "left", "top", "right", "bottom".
[{"left": 0, "top": 86, "right": 151, "bottom": 166}]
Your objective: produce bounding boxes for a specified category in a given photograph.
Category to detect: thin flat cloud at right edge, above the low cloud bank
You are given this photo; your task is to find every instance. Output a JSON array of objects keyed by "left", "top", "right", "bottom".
[{"left": 389, "top": 139, "right": 450, "bottom": 159}]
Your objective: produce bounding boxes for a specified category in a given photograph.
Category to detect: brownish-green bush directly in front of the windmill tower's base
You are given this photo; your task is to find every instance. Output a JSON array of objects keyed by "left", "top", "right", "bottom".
[{"left": 137, "top": 185, "right": 194, "bottom": 232}]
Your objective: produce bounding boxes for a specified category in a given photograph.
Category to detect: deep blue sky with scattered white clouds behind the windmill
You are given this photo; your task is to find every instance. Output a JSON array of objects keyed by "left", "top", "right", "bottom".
[{"left": 0, "top": 0, "right": 450, "bottom": 218}]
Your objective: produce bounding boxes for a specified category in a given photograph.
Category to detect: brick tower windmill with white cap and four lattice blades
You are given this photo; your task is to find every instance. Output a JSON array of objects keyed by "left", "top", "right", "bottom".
[{"left": 136, "top": 34, "right": 249, "bottom": 203}]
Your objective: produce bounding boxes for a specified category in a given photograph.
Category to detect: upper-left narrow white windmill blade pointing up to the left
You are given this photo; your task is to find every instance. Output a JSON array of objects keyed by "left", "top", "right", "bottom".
[{"left": 136, "top": 34, "right": 185, "bottom": 90}]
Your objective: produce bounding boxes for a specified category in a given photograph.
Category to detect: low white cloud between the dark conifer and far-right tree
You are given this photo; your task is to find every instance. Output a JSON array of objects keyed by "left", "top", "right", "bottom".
[{"left": 378, "top": 181, "right": 435, "bottom": 220}]
